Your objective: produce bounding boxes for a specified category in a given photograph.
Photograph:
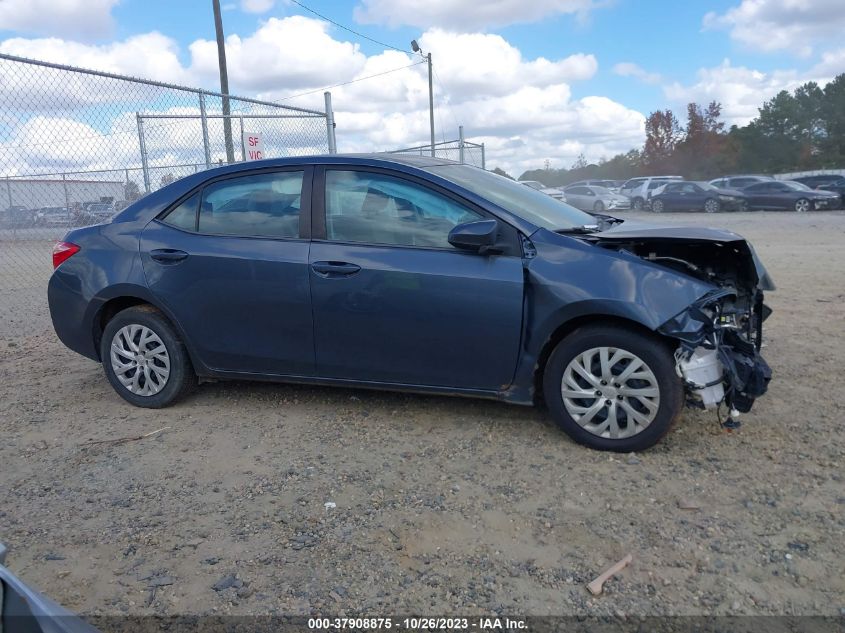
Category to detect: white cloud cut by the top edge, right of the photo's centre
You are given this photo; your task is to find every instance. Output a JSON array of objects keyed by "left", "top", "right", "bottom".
[{"left": 354, "top": 0, "right": 600, "bottom": 31}]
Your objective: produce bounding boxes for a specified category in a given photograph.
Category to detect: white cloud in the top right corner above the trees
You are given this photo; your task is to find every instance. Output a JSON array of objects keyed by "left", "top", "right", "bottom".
[{"left": 704, "top": 0, "right": 845, "bottom": 57}]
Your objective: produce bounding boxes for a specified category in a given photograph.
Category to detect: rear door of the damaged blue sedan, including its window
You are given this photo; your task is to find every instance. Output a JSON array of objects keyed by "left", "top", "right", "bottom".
[{"left": 141, "top": 167, "right": 314, "bottom": 375}]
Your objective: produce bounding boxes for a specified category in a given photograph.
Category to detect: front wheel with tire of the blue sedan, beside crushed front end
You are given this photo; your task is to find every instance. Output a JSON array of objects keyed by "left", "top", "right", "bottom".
[{"left": 543, "top": 325, "right": 684, "bottom": 452}]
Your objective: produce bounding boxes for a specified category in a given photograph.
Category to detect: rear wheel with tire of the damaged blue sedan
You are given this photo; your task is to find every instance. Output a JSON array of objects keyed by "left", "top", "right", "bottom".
[{"left": 100, "top": 306, "right": 197, "bottom": 409}]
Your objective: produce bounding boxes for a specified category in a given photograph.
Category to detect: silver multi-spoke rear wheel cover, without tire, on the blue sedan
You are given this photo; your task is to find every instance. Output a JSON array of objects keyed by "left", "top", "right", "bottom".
[{"left": 110, "top": 325, "right": 170, "bottom": 396}]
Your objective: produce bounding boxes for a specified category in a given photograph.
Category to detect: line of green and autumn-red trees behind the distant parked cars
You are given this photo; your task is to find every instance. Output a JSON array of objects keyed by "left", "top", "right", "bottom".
[{"left": 520, "top": 73, "right": 845, "bottom": 187}]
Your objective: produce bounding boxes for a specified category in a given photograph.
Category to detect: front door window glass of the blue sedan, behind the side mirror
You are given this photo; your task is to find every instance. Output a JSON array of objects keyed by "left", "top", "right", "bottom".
[{"left": 326, "top": 170, "right": 484, "bottom": 248}]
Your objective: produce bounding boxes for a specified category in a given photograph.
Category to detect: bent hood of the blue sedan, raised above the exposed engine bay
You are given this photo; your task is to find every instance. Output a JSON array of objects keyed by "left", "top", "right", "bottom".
[{"left": 587, "top": 220, "right": 775, "bottom": 290}]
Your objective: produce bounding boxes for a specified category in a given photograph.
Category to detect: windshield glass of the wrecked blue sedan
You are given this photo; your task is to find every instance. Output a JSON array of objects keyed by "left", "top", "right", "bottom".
[{"left": 425, "top": 165, "right": 595, "bottom": 231}]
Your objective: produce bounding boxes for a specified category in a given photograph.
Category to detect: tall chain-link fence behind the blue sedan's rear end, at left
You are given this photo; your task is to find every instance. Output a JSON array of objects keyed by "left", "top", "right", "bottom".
[{"left": 0, "top": 54, "right": 334, "bottom": 306}]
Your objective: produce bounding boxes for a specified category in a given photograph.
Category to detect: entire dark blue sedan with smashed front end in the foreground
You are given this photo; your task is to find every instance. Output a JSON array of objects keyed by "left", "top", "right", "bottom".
[{"left": 47, "top": 154, "right": 774, "bottom": 452}]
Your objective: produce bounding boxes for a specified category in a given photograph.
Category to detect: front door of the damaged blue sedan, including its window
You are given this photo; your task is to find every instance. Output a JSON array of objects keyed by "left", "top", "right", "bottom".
[{"left": 310, "top": 166, "right": 523, "bottom": 390}]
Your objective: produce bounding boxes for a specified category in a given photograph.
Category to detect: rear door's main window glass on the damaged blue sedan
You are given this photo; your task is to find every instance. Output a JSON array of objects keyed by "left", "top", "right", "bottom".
[{"left": 198, "top": 171, "right": 303, "bottom": 238}]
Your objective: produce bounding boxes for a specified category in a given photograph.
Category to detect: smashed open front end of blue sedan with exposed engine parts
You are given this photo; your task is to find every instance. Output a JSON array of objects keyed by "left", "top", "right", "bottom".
[{"left": 595, "top": 229, "right": 774, "bottom": 427}]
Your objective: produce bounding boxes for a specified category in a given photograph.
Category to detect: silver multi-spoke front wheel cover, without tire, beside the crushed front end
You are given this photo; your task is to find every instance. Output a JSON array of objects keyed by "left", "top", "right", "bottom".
[{"left": 561, "top": 347, "right": 660, "bottom": 439}]
